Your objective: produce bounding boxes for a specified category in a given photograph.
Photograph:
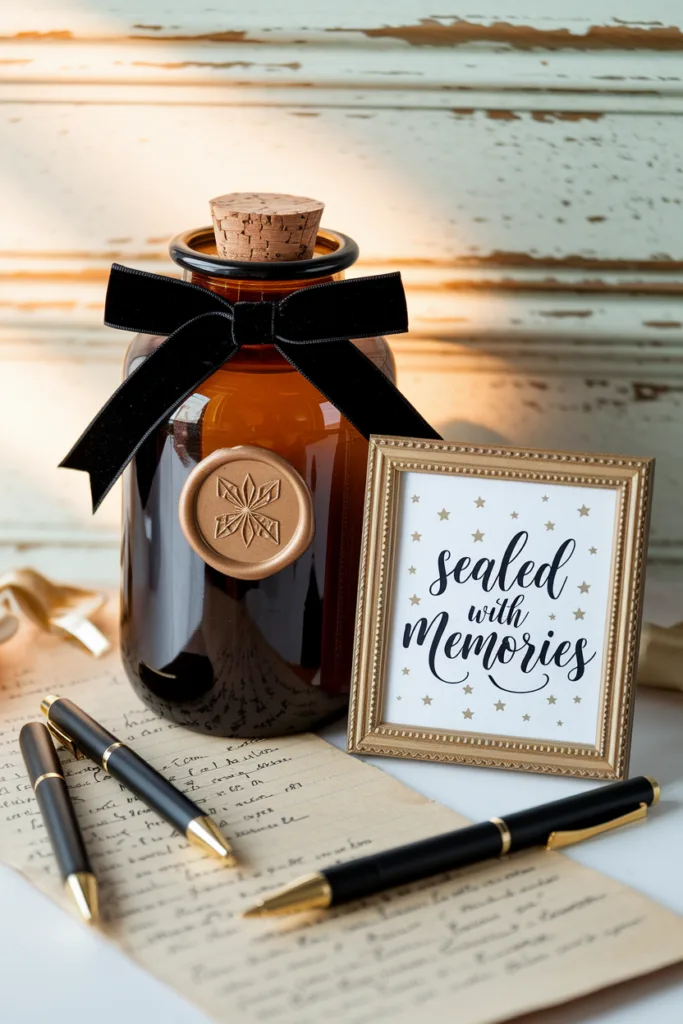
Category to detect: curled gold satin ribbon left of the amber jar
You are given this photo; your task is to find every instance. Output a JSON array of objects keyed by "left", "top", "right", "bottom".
[{"left": 0, "top": 568, "right": 112, "bottom": 657}]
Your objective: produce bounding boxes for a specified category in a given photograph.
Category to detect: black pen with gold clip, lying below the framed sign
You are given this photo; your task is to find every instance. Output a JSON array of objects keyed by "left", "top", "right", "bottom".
[{"left": 243, "top": 775, "right": 659, "bottom": 918}]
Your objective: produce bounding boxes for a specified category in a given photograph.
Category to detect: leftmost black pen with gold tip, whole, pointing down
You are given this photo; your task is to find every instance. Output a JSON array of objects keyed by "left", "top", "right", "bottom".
[{"left": 19, "top": 722, "right": 99, "bottom": 925}]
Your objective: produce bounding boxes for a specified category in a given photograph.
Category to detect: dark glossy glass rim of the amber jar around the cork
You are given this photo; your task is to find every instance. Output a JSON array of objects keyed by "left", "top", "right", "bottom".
[{"left": 168, "top": 226, "right": 358, "bottom": 281}]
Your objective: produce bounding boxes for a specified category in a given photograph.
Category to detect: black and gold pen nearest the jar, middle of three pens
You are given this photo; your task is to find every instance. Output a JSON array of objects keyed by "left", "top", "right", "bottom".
[{"left": 40, "top": 695, "right": 237, "bottom": 866}]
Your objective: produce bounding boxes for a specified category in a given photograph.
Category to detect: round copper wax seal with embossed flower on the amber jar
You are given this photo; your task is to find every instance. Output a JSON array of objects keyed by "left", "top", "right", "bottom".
[{"left": 178, "top": 444, "right": 314, "bottom": 580}]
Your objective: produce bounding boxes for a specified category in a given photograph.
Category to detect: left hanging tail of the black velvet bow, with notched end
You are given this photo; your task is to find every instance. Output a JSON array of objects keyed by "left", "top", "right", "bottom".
[{"left": 59, "top": 311, "right": 238, "bottom": 512}]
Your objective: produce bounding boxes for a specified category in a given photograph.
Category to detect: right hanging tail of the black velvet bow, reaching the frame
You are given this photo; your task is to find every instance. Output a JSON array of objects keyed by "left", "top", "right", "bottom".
[{"left": 275, "top": 339, "right": 441, "bottom": 440}]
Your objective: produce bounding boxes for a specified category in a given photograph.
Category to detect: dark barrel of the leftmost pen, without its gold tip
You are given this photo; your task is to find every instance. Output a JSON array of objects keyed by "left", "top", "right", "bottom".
[{"left": 19, "top": 722, "right": 92, "bottom": 881}]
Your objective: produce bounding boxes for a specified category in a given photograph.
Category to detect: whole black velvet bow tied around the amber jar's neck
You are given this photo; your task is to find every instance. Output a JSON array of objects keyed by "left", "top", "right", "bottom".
[{"left": 59, "top": 263, "right": 439, "bottom": 512}]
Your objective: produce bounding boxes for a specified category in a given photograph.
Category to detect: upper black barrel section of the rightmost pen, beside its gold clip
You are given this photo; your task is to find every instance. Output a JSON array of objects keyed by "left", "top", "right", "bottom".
[{"left": 505, "top": 775, "right": 657, "bottom": 852}]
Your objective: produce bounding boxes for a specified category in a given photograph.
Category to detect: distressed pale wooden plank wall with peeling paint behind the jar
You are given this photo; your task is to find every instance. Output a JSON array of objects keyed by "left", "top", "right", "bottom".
[{"left": 0, "top": 0, "right": 683, "bottom": 580}]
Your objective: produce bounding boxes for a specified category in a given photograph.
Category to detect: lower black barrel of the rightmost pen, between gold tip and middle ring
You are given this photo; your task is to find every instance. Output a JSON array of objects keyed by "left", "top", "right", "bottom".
[{"left": 324, "top": 821, "right": 503, "bottom": 905}]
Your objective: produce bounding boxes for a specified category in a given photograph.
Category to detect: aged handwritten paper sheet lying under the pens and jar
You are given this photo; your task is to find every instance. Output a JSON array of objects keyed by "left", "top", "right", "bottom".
[{"left": 0, "top": 610, "right": 683, "bottom": 1024}]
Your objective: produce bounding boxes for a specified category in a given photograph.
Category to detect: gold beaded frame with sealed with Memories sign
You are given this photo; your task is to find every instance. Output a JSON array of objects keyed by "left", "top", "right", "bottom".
[{"left": 347, "top": 437, "right": 654, "bottom": 779}]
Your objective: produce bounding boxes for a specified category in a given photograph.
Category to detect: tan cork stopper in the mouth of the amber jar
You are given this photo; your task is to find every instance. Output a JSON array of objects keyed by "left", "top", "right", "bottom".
[{"left": 210, "top": 193, "right": 325, "bottom": 263}]
